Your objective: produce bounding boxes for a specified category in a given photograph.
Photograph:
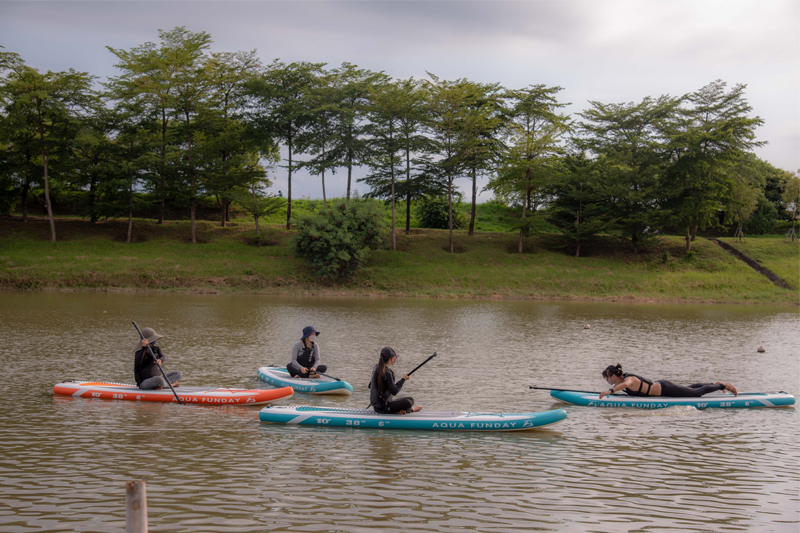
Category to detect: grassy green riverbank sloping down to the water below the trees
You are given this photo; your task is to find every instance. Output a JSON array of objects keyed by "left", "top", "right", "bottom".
[{"left": 0, "top": 214, "right": 800, "bottom": 305}]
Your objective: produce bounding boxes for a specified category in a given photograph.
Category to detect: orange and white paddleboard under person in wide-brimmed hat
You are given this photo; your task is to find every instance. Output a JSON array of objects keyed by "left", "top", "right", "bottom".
[{"left": 53, "top": 381, "right": 294, "bottom": 405}]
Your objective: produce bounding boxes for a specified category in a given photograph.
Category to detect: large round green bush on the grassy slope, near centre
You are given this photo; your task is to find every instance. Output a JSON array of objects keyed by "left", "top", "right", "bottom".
[{"left": 291, "top": 200, "right": 384, "bottom": 280}]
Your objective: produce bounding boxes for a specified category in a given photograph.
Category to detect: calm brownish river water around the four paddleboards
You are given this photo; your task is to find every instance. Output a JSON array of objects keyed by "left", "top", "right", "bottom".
[{"left": 0, "top": 291, "right": 800, "bottom": 533}]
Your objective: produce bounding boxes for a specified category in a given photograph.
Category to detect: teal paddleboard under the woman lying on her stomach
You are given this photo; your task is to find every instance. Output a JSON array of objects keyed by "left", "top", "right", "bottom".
[{"left": 550, "top": 391, "right": 794, "bottom": 409}]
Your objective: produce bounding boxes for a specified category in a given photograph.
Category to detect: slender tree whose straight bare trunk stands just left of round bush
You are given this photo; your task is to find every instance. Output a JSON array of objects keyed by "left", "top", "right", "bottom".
[{"left": 248, "top": 60, "right": 324, "bottom": 229}]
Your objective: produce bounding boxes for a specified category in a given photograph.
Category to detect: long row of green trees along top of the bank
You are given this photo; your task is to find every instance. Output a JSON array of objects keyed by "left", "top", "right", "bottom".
[{"left": 0, "top": 27, "right": 798, "bottom": 255}]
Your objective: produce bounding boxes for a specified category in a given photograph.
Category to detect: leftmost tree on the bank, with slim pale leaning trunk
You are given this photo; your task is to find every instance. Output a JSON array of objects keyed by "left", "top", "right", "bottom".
[{"left": 0, "top": 53, "right": 95, "bottom": 242}]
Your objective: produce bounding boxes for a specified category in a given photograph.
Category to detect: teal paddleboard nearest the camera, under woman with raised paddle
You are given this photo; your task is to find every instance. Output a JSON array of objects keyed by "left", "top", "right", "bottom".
[{"left": 258, "top": 406, "right": 567, "bottom": 431}]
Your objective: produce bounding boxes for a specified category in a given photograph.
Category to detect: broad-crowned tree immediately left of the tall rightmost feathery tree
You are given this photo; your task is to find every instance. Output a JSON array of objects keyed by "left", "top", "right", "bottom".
[{"left": 573, "top": 96, "right": 680, "bottom": 252}]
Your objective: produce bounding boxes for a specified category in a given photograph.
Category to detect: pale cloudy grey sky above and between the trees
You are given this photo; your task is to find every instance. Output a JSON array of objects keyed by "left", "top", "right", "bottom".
[{"left": 0, "top": 0, "right": 800, "bottom": 199}]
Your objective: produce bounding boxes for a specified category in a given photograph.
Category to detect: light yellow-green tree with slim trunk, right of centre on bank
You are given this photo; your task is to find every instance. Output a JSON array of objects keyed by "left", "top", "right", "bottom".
[{"left": 487, "top": 85, "right": 568, "bottom": 253}]
